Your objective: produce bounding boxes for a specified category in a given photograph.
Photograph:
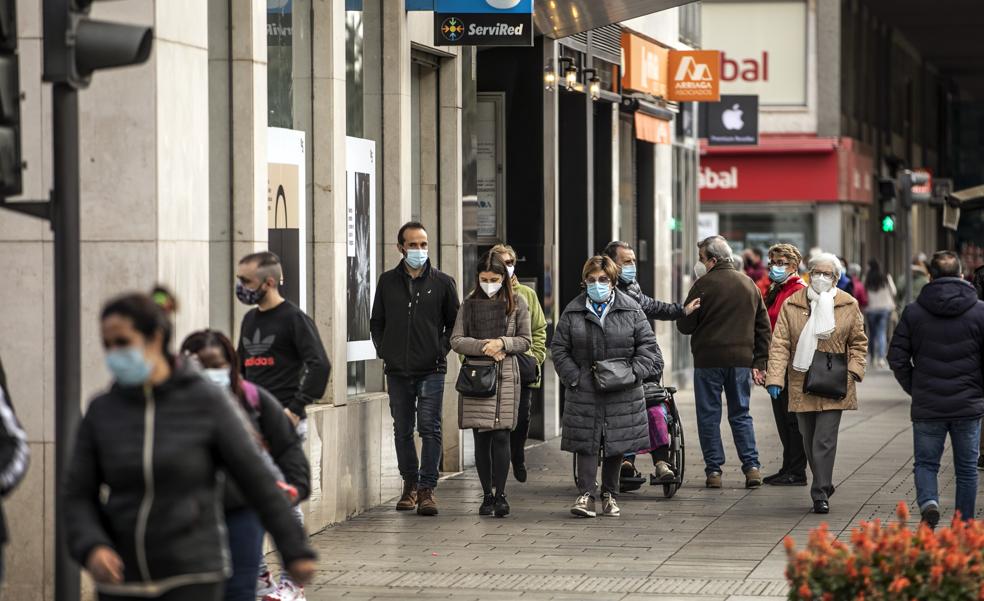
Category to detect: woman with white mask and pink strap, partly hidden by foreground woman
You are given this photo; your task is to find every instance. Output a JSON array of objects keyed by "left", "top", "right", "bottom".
[{"left": 181, "top": 330, "right": 311, "bottom": 601}]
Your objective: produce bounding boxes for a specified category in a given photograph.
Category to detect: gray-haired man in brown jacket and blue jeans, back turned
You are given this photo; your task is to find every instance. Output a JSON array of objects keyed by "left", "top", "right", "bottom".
[{"left": 677, "top": 236, "right": 770, "bottom": 488}]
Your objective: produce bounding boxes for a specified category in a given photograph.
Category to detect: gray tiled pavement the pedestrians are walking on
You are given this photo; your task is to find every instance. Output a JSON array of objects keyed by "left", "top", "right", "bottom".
[{"left": 300, "top": 372, "right": 981, "bottom": 601}]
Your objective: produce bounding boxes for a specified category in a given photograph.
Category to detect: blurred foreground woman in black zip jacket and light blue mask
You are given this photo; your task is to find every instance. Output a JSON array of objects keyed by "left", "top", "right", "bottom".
[{"left": 62, "top": 294, "right": 315, "bottom": 601}]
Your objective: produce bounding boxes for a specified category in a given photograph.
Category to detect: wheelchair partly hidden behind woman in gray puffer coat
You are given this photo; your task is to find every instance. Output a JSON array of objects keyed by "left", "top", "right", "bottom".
[{"left": 574, "top": 382, "right": 684, "bottom": 499}]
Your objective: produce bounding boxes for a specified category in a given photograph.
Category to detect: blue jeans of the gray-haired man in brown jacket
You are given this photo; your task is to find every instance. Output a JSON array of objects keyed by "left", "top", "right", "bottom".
[{"left": 694, "top": 367, "right": 761, "bottom": 475}]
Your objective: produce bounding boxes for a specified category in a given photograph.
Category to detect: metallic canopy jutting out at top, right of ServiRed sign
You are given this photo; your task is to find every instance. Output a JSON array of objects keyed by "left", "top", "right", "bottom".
[{"left": 533, "top": 0, "right": 693, "bottom": 38}]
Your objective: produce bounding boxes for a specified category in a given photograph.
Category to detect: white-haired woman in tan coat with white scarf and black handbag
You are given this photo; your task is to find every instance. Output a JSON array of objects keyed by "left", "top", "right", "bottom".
[{"left": 765, "top": 253, "right": 868, "bottom": 513}]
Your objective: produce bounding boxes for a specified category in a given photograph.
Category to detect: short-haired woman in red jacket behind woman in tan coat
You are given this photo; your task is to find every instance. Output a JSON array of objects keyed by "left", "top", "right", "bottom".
[{"left": 763, "top": 244, "right": 806, "bottom": 486}]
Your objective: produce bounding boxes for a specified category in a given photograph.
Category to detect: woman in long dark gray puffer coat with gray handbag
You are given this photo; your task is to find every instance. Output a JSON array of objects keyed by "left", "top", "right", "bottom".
[{"left": 550, "top": 256, "right": 663, "bottom": 517}]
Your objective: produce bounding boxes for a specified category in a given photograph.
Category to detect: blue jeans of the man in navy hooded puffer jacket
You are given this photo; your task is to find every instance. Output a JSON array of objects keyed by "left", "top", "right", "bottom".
[{"left": 912, "top": 419, "right": 981, "bottom": 520}]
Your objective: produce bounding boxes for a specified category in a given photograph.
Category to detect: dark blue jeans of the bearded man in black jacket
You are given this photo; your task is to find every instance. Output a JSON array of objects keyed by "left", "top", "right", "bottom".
[{"left": 386, "top": 374, "right": 444, "bottom": 488}]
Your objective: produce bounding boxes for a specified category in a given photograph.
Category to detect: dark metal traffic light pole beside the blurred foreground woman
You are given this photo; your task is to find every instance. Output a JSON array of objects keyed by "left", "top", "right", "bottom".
[{"left": 51, "top": 83, "right": 82, "bottom": 601}]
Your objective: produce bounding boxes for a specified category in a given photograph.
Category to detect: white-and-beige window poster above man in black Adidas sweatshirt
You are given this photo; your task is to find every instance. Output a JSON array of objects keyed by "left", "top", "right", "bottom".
[{"left": 267, "top": 127, "right": 307, "bottom": 311}]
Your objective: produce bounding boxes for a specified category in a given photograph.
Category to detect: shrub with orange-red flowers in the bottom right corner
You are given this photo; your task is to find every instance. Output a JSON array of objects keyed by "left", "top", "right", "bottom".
[{"left": 784, "top": 503, "right": 984, "bottom": 601}]
